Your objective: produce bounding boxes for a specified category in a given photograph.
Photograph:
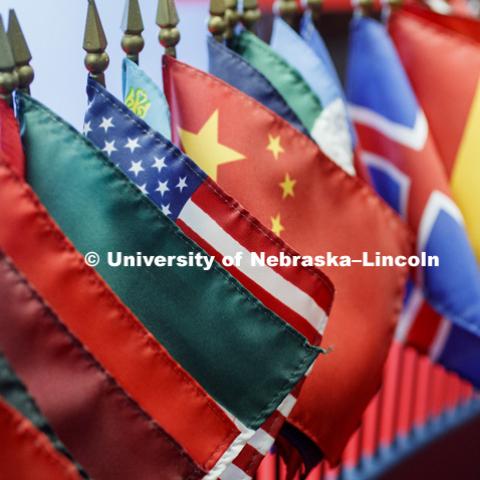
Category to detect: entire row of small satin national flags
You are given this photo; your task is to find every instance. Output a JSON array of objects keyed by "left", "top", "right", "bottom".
[{"left": 0, "top": 0, "right": 480, "bottom": 480}]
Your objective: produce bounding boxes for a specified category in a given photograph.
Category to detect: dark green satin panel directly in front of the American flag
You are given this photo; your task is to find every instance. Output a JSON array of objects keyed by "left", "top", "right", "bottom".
[{"left": 20, "top": 95, "right": 318, "bottom": 429}]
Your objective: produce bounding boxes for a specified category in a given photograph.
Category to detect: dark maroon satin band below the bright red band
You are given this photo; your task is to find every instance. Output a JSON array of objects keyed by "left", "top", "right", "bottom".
[{"left": 0, "top": 253, "right": 205, "bottom": 480}]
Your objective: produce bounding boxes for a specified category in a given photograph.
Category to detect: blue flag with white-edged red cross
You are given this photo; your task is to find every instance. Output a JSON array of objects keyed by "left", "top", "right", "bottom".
[{"left": 347, "top": 17, "right": 480, "bottom": 385}]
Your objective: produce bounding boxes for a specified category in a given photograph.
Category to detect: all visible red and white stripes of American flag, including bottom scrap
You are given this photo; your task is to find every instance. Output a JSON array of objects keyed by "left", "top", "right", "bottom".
[{"left": 177, "top": 180, "right": 333, "bottom": 480}]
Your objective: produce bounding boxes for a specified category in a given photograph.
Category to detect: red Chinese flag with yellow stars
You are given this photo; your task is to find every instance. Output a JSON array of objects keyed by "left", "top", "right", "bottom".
[{"left": 164, "top": 57, "right": 411, "bottom": 462}]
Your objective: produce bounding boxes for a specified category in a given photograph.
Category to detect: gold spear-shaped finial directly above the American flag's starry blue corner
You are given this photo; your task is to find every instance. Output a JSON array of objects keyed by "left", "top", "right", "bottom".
[{"left": 83, "top": 0, "right": 110, "bottom": 86}]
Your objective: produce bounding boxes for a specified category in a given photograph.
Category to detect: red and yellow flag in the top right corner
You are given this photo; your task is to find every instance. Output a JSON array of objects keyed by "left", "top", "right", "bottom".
[{"left": 389, "top": 6, "right": 480, "bottom": 261}]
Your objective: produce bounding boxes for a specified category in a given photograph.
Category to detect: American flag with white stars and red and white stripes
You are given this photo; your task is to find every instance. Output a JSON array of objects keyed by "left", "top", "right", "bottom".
[{"left": 84, "top": 78, "right": 333, "bottom": 479}]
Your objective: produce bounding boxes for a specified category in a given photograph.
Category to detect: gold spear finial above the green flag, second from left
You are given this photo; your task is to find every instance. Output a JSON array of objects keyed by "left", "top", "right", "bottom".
[{"left": 7, "top": 9, "right": 35, "bottom": 93}]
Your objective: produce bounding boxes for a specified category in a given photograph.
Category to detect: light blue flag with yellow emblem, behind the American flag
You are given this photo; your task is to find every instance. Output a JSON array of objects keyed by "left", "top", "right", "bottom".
[{"left": 122, "top": 58, "right": 172, "bottom": 140}]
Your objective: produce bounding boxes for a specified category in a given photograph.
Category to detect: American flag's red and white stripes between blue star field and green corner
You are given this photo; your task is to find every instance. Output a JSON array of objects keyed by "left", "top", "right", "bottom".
[{"left": 177, "top": 180, "right": 333, "bottom": 345}]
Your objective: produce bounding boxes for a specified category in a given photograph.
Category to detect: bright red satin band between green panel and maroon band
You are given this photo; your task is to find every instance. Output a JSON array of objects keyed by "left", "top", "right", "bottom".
[{"left": 0, "top": 161, "right": 234, "bottom": 469}]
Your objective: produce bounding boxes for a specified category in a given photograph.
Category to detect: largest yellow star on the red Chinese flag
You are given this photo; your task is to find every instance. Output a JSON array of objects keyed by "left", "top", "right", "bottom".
[{"left": 179, "top": 110, "right": 245, "bottom": 180}]
